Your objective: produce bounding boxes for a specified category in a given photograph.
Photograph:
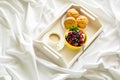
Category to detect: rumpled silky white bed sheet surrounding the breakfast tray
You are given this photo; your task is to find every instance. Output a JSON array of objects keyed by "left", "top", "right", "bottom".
[{"left": 0, "top": 0, "right": 120, "bottom": 80}]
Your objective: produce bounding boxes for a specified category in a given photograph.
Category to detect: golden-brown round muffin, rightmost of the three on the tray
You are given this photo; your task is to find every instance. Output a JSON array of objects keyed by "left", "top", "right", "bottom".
[{"left": 76, "top": 15, "right": 89, "bottom": 28}]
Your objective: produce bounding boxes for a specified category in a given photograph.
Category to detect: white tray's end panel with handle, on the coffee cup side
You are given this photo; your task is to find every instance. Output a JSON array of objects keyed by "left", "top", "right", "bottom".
[{"left": 34, "top": 41, "right": 67, "bottom": 67}]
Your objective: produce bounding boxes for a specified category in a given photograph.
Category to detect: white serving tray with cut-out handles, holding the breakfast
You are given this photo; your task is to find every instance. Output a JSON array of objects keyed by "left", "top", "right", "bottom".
[{"left": 34, "top": 4, "right": 102, "bottom": 67}]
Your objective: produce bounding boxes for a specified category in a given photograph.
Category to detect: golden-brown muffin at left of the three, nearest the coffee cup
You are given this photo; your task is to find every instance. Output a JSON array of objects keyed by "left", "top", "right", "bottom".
[{"left": 64, "top": 17, "right": 77, "bottom": 29}]
